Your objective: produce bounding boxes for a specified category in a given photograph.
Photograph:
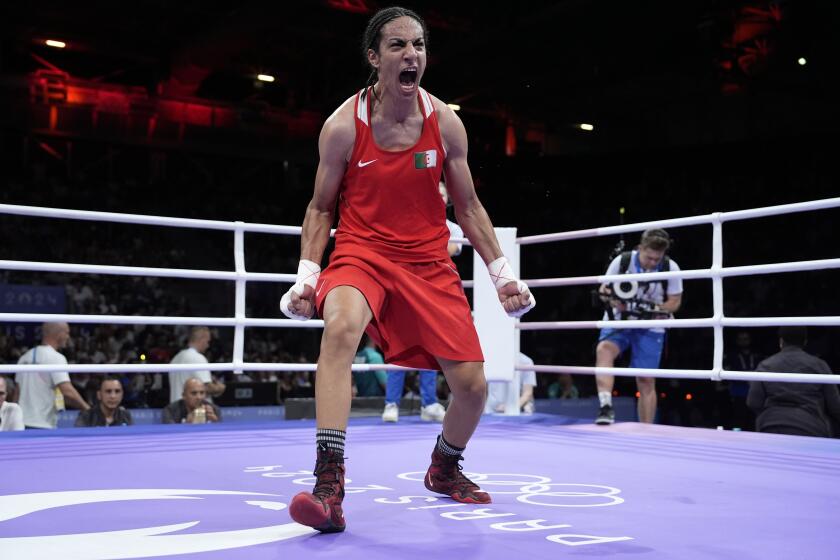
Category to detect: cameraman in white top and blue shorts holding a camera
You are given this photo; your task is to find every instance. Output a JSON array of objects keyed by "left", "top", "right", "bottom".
[{"left": 595, "top": 229, "right": 682, "bottom": 425}]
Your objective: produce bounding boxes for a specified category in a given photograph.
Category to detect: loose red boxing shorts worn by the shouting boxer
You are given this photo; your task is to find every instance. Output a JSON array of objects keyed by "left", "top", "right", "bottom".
[{"left": 315, "top": 246, "right": 484, "bottom": 370}]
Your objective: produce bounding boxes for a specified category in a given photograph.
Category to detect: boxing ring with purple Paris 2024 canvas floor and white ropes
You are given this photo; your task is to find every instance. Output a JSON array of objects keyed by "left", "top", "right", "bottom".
[{"left": 0, "top": 198, "right": 840, "bottom": 560}]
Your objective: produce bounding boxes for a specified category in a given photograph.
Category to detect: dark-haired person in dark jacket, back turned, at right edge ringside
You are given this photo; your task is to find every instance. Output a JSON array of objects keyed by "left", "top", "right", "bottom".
[{"left": 747, "top": 327, "right": 840, "bottom": 437}]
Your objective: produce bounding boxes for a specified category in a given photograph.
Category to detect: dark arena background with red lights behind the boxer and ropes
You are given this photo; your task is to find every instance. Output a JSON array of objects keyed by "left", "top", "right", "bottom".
[{"left": 0, "top": 0, "right": 840, "bottom": 425}]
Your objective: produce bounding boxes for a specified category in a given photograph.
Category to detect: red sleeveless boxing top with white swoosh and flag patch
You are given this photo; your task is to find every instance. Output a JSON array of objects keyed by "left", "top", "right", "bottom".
[{"left": 335, "top": 89, "right": 449, "bottom": 262}]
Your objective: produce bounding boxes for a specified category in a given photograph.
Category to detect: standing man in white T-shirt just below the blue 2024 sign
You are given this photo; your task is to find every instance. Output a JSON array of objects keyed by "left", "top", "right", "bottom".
[{"left": 15, "top": 323, "right": 90, "bottom": 429}]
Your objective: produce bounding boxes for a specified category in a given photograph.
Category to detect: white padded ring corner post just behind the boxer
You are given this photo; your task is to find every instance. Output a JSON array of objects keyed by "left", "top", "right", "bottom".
[{"left": 473, "top": 228, "right": 521, "bottom": 415}]
